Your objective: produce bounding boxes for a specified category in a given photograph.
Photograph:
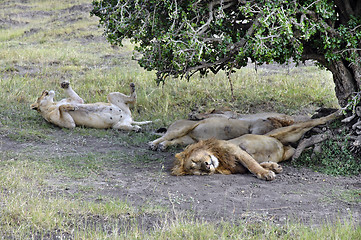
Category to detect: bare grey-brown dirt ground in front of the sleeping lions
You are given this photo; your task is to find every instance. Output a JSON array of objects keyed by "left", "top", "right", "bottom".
[{"left": 0, "top": 128, "right": 361, "bottom": 225}]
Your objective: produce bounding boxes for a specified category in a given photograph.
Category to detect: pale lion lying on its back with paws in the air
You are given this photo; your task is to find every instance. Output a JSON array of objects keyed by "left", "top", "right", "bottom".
[{"left": 30, "top": 81, "right": 152, "bottom": 131}]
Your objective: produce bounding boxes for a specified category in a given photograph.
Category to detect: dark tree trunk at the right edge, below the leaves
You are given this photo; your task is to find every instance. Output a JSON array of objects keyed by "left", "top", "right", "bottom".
[{"left": 327, "top": 60, "right": 361, "bottom": 107}]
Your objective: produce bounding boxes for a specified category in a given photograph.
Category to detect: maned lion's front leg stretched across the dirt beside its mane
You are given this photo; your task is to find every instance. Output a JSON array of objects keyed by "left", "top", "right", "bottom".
[{"left": 226, "top": 143, "right": 276, "bottom": 181}]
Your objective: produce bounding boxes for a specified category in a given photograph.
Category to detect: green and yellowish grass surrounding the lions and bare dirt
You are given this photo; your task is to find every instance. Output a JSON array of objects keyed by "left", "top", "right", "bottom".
[{"left": 0, "top": 0, "right": 361, "bottom": 239}]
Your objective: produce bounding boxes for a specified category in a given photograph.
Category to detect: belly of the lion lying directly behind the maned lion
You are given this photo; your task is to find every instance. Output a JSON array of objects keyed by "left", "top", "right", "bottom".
[{"left": 190, "top": 118, "right": 249, "bottom": 140}]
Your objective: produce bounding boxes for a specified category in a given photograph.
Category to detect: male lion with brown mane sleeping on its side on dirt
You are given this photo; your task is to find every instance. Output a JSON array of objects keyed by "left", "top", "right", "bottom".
[{"left": 172, "top": 110, "right": 340, "bottom": 181}]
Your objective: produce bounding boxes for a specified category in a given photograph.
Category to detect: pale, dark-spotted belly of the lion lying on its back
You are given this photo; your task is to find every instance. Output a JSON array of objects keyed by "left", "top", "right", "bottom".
[{"left": 69, "top": 104, "right": 123, "bottom": 128}]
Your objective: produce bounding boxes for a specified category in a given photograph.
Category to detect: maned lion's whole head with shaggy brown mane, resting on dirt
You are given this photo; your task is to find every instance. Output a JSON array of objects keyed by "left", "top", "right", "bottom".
[{"left": 172, "top": 138, "right": 245, "bottom": 176}]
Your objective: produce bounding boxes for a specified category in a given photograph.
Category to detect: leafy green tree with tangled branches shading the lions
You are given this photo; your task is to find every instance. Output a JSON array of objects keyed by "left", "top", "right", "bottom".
[{"left": 92, "top": 0, "right": 361, "bottom": 106}]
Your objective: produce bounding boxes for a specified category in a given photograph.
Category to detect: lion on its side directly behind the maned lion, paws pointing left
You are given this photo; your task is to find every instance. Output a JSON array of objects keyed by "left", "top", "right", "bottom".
[{"left": 148, "top": 113, "right": 294, "bottom": 150}]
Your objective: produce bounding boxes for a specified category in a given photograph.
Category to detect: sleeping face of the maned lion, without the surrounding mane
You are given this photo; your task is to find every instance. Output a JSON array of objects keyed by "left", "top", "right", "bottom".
[{"left": 172, "top": 149, "right": 219, "bottom": 176}]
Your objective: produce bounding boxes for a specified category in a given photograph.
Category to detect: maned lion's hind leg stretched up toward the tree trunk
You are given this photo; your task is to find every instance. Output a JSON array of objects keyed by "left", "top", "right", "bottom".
[{"left": 265, "top": 110, "right": 341, "bottom": 144}]
